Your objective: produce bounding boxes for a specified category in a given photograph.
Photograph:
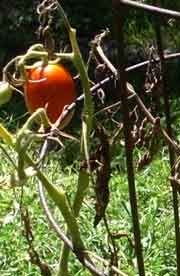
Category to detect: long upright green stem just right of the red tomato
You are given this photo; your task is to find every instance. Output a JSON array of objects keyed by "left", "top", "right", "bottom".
[{"left": 57, "top": 3, "right": 93, "bottom": 276}]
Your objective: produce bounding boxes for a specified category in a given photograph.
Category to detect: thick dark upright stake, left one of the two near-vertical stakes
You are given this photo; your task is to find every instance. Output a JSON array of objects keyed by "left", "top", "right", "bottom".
[{"left": 112, "top": 1, "right": 145, "bottom": 276}]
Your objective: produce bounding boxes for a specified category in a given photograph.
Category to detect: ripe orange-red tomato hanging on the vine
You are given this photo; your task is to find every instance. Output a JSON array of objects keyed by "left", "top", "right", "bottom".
[{"left": 25, "top": 64, "right": 76, "bottom": 123}]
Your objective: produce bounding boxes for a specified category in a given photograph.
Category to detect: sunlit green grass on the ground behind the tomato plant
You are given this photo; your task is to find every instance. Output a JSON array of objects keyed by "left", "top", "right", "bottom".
[{"left": 0, "top": 142, "right": 176, "bottom": 276}]
